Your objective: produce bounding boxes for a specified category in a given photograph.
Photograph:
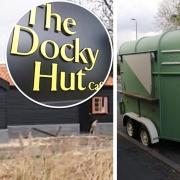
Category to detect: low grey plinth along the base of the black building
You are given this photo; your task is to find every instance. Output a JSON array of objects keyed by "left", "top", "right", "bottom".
[{"left": 0, "top": 123, "right": 113, "bottom": 143}]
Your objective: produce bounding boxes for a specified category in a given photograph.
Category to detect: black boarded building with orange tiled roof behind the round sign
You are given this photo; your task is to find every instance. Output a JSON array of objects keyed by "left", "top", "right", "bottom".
[{"left": 0, "top": 65, "right": 113, "bottom": 132}]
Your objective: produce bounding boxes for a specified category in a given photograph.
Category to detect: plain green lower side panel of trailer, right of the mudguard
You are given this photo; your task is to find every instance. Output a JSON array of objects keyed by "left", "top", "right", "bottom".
[{"left": 160, "top": 74, "right": 180, "bottom": 141}]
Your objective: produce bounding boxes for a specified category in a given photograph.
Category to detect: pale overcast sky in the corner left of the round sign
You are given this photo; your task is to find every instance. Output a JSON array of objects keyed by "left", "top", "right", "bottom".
[{"left": 0, "top": 0, "right": 63, "bottom": 63}]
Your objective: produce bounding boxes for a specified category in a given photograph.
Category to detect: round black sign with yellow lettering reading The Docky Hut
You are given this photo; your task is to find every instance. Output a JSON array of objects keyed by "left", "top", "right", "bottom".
[{"left": 7, "top": 2, "right": 112, "bottom": 108}]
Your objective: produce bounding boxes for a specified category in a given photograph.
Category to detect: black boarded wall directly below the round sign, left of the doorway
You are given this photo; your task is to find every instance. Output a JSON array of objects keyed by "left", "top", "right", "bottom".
[{"left": 7, "top": 88, "right": 79, "bottom": 125}]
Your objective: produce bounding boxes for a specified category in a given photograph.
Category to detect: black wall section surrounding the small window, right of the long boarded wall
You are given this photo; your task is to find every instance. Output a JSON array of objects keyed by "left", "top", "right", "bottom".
[{"left": 79, "top": 87, "right": 113, "bottom": 132}]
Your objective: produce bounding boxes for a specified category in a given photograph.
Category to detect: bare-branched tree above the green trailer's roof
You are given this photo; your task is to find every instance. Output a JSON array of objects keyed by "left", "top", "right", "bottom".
[{"left": 155, "top": 0, "right": 180, "bottom": 30}]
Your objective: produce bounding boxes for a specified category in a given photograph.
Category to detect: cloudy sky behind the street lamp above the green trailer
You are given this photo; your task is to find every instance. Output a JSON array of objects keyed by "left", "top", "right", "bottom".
[{"left": 117, "top": 0, "right": 162, "bottom": 47}]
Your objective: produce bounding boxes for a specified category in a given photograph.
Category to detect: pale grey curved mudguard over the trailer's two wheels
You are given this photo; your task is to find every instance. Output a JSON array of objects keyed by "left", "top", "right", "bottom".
[{"left": 123, "top": 112, "right": 159, "bottom": 144}]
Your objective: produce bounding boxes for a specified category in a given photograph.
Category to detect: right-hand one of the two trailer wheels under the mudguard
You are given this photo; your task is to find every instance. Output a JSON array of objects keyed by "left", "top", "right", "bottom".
[{"left": 139, "top": 127, "right": 151, "bottom": 146}]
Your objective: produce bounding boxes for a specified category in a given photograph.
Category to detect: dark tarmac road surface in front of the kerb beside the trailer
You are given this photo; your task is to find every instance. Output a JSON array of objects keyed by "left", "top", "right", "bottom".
[{"left": 117, "top": 136, "right": 180, "bottom": 180}]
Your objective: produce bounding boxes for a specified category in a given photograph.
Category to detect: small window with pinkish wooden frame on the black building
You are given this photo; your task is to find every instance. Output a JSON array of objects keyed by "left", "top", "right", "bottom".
[{"left": 92, "top": 97, "right": 108, "bottom": 114}]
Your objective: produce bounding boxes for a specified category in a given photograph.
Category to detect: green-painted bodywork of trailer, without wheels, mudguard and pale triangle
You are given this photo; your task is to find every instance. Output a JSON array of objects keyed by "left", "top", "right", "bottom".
[{"left": 120, "top": 30, "right": 180, "bottom": 141}]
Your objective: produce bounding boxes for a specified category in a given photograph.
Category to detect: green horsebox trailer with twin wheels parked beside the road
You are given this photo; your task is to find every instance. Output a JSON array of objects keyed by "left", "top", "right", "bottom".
[{"left": 119, "top": 30, "right": 180, "bottom": 145}]
